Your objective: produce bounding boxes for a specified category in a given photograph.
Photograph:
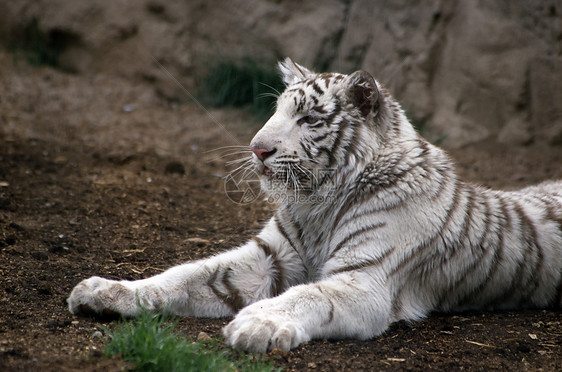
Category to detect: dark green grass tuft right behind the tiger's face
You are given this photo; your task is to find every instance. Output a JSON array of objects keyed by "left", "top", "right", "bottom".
[{"left": 199, "top": 57, "right": 285, "bottom": 120}]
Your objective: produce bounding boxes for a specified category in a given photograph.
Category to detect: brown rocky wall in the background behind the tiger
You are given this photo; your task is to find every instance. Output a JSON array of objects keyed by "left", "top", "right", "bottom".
[{"left": 0, "top": 0, "right": 562, "bottom": 146}]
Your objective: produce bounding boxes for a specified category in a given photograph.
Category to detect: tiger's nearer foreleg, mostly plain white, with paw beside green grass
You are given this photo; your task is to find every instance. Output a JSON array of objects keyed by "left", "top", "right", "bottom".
[{"left": 223, "top": 272, "right": 390, "bottom": 352}]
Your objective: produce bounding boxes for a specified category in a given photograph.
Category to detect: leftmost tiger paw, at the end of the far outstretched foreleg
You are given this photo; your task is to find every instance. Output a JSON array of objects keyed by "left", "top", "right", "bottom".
[{"left": 66, "top": 276, "right": 135, "bottom": 316}]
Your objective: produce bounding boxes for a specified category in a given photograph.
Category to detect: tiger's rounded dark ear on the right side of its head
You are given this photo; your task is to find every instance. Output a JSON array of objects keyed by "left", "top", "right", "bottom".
[{"left": 347, "top": 70, "right": 379, "bottom": 117}]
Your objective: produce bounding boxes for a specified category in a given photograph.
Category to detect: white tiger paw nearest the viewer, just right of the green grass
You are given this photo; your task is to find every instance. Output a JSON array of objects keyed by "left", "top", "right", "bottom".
[{"left": 223, "top": 306, "right": 310, "bottom": 353}]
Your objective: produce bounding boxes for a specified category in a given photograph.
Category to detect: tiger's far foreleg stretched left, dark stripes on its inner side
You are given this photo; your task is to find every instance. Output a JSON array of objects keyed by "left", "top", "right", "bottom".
[{"left": 67, "top": 221, "right": 304, "bottom": 317}]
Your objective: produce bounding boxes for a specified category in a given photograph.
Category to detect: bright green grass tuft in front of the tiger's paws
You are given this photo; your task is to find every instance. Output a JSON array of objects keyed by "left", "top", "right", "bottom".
[{"left": 105, "top": 311, "right": 275, "bottom": 372}]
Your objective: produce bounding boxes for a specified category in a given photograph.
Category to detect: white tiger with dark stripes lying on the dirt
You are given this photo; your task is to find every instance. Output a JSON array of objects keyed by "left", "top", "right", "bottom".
[{"left": 68, "top": 59, "right": 562, "bottom": 352}]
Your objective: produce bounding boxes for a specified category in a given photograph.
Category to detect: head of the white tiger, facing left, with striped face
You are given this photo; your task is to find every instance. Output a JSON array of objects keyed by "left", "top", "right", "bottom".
[{"left": 250, "top": 58, "right": 414, "bottom": 203}]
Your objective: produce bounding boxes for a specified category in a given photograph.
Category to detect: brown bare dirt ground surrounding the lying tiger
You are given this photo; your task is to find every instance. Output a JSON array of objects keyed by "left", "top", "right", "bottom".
[{"left": 0, "top": 52, "right": 562, "bottom": 372}]
